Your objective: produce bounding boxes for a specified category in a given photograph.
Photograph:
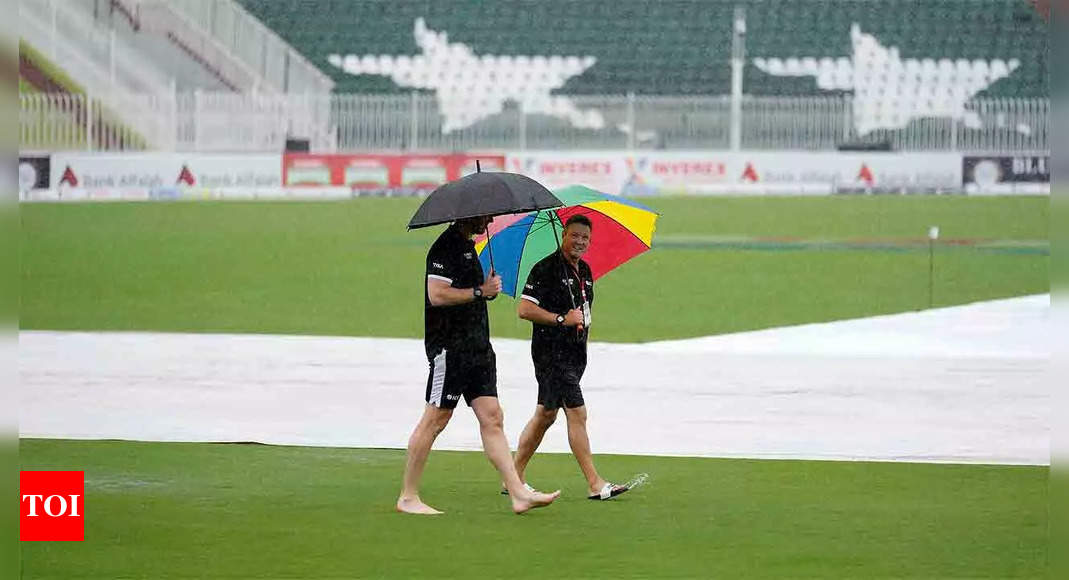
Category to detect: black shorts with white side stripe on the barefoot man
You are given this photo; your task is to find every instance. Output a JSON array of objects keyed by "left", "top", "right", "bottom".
[{"left": 424, "top": 349, "right": 497, "bottom": 409}]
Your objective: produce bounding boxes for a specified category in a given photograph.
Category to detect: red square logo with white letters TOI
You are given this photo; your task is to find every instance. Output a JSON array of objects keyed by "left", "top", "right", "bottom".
[{"left": 18, "top": 471, "right": 86, "bottom": 542}]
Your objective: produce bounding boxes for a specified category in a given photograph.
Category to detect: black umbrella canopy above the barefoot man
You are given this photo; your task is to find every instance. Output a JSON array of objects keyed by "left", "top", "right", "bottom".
[{"left": 408, "top": 172, "right": 562, "bottom": 230}]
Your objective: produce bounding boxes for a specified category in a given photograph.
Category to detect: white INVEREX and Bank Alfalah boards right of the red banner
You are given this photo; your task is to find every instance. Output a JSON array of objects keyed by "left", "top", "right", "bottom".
[{"left": 507, "top": 152, "right": 961, "bottom": 195}]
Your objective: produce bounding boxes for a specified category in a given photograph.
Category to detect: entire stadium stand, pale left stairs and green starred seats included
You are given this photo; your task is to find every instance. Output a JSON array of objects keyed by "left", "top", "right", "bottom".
[{"left": 19, "top": 0, "right": 1050, "bottom": 151}]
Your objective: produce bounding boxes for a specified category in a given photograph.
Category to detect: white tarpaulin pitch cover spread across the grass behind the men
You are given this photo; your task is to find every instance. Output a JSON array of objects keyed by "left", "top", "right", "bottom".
[{"left": 19, "top": 295, "right": 1051, "bottom": 465}]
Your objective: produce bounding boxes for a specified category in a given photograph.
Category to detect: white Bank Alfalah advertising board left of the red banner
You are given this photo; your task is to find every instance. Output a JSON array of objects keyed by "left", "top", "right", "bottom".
[{"left": 50, "top": 153, "right": 282, "bottom": 190}]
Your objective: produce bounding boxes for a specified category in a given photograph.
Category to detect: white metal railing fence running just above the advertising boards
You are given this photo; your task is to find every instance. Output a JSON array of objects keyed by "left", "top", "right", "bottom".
[{"left": 20, "top": 93, "right": 1050, "bottom": 153}]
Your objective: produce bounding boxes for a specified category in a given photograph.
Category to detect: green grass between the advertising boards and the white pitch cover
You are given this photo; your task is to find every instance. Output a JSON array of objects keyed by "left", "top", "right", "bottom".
[{"left": 20, "top": 197, "right": 1049, "bottom": 342}]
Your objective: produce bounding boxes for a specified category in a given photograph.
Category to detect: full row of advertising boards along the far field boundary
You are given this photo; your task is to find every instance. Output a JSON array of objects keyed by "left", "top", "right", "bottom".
[{"left": 19, "top": 151, "right": 1050, "bottom": 202}]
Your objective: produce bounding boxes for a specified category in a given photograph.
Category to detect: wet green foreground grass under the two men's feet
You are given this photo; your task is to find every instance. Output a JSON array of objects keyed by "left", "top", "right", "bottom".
[{"left": 20, "top": 440, "right": 1048, "bottom": 580}]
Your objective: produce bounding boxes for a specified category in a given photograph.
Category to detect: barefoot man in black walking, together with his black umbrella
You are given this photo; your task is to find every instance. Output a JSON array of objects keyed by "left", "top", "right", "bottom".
[{"left": 397, "top": 168, "right": 560, "bottom": 514}]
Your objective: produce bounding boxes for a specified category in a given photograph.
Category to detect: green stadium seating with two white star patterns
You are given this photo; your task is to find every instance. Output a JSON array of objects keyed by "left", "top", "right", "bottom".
[{"left": 227, "top": 0, "right": 1050, "bottom": 148}]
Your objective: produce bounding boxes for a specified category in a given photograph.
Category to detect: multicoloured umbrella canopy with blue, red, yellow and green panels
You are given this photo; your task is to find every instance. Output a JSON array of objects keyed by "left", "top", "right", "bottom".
[{"left": 475, "top": 185, "right": 659, "bottom": 298}]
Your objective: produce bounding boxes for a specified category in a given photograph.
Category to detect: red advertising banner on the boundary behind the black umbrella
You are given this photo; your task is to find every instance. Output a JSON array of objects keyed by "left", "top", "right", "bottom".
[{"left": 282, "top": 153, "right": 505, "bottom": 194}]
